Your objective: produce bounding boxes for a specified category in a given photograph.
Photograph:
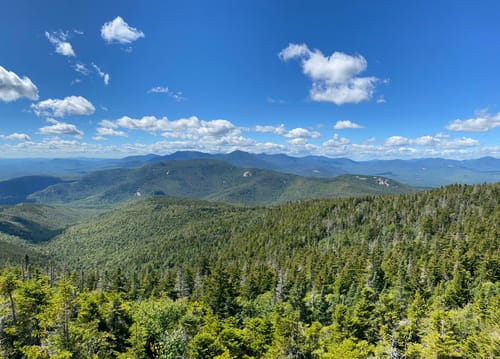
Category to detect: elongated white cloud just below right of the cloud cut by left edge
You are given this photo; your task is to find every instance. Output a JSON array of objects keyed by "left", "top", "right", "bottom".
[{"left": 31, "top": 96, "right": 95, "bottom": 117}]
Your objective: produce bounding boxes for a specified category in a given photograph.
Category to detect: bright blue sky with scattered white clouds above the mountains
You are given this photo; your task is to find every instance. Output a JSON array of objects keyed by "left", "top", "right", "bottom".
[{"left": 0, "top": 0, "right": 500, "bottom": 160}]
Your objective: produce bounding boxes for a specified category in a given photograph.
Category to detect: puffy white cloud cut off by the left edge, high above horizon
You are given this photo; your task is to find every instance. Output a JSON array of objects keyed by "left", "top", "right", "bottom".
[{"left": 0, "top": 66, "right": 38, "bottom": 102}]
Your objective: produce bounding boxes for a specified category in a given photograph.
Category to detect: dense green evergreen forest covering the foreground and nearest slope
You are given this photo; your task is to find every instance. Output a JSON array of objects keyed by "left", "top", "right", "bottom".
[{"left": 0, "top": 184, "right": 500, "bottom": 359}]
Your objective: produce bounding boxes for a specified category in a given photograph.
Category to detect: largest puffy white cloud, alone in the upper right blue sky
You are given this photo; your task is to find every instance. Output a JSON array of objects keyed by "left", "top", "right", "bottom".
[{"left": 279, "top": 44, "right": 379, "bottom": 105}]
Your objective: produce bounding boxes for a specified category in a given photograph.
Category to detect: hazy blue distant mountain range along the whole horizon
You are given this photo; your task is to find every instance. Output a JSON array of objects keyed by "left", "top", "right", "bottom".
[{"left": 0, "top": 151, "right": 500, "bottom": 187}]
